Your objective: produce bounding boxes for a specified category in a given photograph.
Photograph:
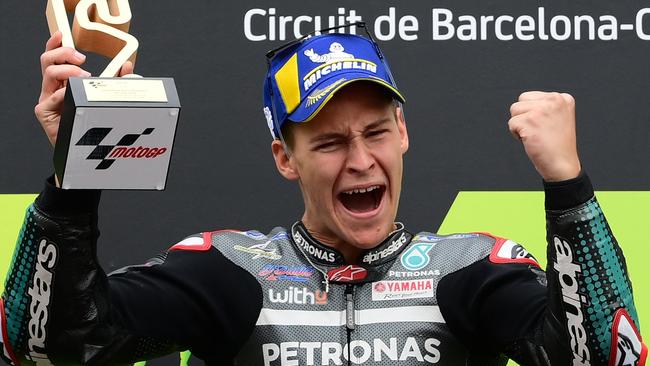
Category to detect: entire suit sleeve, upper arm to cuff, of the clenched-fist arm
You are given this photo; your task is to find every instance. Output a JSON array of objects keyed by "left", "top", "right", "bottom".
[{"left": 438, "top": 174, "right": 647, "bottom": 366}]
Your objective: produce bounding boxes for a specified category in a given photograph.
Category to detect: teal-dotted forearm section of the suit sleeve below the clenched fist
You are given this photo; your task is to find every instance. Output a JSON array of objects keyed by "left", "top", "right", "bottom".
[{"left": 544, "top": 175, "right": 647, "bottom": 366}]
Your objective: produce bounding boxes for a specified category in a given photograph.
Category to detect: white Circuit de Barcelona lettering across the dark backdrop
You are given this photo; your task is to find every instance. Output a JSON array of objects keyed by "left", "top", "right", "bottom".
[{"left": 243, "top": 7, "right": 650, "bottom": 41}]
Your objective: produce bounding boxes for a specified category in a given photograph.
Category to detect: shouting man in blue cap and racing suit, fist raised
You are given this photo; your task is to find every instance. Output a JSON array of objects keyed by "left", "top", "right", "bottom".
[{"left": 0, "top": 27, "right": 647, "bottom": 365}]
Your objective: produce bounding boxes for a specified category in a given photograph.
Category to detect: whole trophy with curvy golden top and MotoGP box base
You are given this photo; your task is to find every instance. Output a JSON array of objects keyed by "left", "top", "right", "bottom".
[{"left": 46, "top": 0, "right": 180, "bottom": 190}]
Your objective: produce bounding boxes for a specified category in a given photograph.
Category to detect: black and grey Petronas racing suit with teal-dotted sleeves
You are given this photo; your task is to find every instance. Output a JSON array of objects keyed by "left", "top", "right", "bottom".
[{"left": 0, "top": 174, "right": 647, "bottom": 366}]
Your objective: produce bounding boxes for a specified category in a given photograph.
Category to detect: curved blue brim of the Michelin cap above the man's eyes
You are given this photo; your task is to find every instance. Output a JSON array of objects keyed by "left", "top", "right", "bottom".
[{"left": 288, "top": 72, "right": 406, "bottom": 122}]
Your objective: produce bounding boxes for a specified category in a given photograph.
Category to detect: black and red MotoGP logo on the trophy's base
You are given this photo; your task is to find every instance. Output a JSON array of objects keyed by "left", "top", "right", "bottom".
[{"left": 75, "top": 127, "right": 167, "bottom": 170}]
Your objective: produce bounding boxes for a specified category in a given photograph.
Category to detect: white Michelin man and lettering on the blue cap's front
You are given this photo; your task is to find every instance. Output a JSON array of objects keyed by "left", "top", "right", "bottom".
[{"left": 303, "top": 42, "right": 377, "bottom": 91}]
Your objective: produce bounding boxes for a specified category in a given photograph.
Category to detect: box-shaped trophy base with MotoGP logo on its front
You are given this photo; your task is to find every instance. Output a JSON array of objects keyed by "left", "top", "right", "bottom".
[{"left": 54, "top": 78, "right": 180, "bottom": 190}]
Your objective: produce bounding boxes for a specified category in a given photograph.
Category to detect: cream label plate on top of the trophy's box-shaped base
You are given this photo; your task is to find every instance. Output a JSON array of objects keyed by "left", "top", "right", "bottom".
[{"left": 83, "top": 78, "right": 168, "bottom": 102}]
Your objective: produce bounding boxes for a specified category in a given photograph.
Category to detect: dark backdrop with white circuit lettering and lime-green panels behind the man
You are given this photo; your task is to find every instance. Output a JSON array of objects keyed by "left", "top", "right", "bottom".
[{"left": 0, "top": 0, "right": 650, "bottom": 365}]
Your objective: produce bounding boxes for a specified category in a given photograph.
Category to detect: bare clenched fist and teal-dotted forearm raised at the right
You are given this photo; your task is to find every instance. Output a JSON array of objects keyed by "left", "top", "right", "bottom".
[{"left": 508, "top": 91, "right": 648, "bottom": 366}]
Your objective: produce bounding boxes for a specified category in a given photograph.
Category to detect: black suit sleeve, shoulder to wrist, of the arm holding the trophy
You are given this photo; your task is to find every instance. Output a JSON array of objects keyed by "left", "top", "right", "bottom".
[{"left": 0, "top": 177, "right": 262, "bottom": 365}]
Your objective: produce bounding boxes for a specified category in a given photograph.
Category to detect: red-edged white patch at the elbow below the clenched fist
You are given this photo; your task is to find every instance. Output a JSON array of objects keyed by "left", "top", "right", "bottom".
[{"left": 609, "top": 309, "right": 648, "bottom": 366}]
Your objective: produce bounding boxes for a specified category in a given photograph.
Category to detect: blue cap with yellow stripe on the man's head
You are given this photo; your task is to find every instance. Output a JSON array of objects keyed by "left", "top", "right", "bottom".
[{"left": 264, "top": 33, "right": 405, "bottom": 138}]
